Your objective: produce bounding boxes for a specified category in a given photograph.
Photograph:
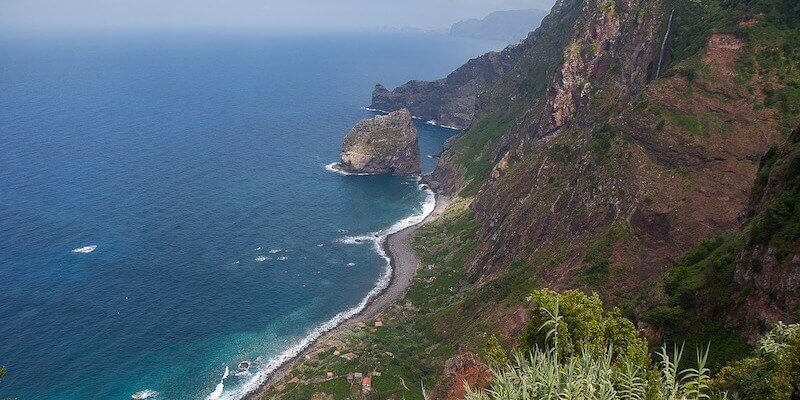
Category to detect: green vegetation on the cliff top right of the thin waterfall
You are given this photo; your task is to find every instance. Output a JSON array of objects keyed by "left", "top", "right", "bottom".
[{"left": 668, "top": 0, "right": 800, "bottom": 131}]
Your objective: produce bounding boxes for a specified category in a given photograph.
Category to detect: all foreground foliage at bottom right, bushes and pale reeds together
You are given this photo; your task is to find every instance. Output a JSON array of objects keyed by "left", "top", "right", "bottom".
[{"left": 467, "top": 291, "right": 800, "bottom": 400}]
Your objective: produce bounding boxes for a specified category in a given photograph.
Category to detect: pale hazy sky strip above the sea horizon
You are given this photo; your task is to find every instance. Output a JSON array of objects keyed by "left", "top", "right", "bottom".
[{"left": 0, "top": 0, "right": 554, "bottom": 30}]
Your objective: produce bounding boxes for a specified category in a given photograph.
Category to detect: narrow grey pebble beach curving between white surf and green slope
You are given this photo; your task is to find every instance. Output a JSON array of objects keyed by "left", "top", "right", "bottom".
[{"left": 242, "top": 192, "right": 450, "bottom": 400}]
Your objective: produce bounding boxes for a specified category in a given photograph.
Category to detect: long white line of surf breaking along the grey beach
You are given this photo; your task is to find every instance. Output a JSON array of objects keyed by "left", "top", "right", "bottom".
[{"left": 216, "top": 182, "right": 436, "bottom": 400}]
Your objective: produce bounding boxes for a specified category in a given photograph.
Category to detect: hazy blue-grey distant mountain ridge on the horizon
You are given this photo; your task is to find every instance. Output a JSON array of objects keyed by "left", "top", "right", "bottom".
[{"left": 450, "top": 9, "right": 549, "bottom": 43}]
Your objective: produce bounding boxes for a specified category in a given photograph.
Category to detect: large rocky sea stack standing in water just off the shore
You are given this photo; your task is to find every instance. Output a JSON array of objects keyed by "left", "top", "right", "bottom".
[{"left": 339, "top": 109, "right": 420, "bottom": 175}]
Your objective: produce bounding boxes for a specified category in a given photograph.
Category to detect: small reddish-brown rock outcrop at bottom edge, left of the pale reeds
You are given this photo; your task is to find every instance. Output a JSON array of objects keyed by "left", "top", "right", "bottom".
[{"left": 431, "top": 353, "right": 492, "bottom": 400}]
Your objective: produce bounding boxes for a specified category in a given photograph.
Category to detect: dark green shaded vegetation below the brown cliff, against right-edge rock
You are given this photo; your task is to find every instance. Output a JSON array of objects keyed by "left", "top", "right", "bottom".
[{"left": 640, "top": 125, "right": 800, "bottom": 370}]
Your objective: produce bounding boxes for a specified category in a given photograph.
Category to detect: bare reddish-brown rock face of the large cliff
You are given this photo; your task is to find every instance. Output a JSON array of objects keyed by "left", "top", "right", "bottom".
[{"left": 470, "top": 25, "right": 779, "bottom": 290}]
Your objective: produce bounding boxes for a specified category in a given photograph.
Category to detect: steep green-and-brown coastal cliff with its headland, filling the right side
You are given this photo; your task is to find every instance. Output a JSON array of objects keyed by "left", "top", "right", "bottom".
[{"left": 264, "top": 0, "right": 800, "bottom": 399}]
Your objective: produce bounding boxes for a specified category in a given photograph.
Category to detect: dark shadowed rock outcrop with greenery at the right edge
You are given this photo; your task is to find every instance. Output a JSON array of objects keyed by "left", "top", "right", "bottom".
[{"left": 732, "top": 128, "right": 800, "bottom": 338}]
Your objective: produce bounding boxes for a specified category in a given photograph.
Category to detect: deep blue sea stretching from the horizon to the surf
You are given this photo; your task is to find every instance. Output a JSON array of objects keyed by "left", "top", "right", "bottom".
[{"left": 0, "top": 33, "right": 502, "bottom": 400}]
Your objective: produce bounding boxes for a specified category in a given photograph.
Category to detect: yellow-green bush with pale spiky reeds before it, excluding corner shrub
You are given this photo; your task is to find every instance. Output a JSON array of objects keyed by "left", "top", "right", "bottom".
[{"left": 466, "top": 290, "right": 712, "bottom": 400}]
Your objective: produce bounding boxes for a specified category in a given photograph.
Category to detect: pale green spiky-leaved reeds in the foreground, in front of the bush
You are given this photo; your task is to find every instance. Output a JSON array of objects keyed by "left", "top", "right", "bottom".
[{"left": 465, "top": 296, "right": 725, "bottom": 400}]
